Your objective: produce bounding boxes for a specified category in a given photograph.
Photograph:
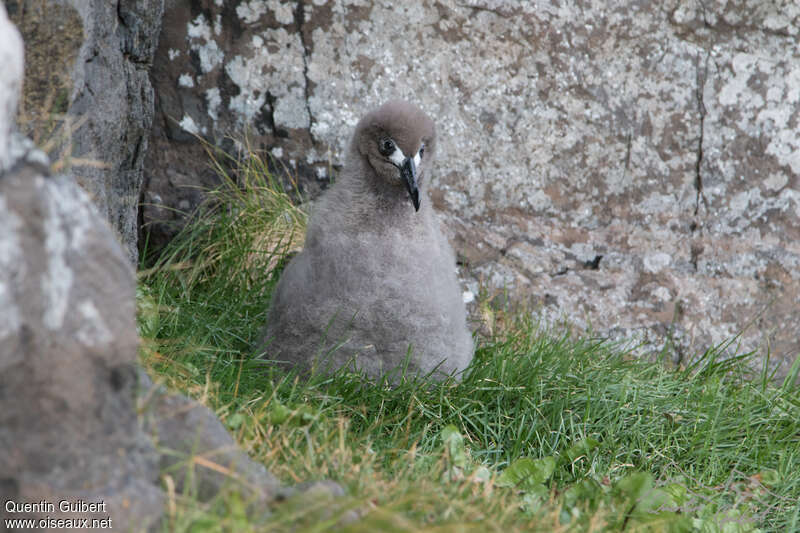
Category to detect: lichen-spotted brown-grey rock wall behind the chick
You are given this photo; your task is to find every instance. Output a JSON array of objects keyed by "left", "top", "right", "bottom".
[{"left": 144, "top": 0, "right": 800, "bottom": 374}]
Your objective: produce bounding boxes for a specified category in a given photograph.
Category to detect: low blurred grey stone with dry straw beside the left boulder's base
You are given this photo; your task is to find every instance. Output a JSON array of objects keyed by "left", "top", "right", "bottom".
[{"left": 140, "top": 372, "right": 282, "bottom": 504}]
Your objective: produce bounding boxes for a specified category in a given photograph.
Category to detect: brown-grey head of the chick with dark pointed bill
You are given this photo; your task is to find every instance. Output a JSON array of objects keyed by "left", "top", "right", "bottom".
[{"left": 353, "top": 100, "right": 436, "bottom": 211}]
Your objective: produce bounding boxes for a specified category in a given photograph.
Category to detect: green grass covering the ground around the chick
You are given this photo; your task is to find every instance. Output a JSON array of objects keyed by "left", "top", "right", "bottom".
[{"left": 138, "top": 142, "right": 800, "bottom": 532}]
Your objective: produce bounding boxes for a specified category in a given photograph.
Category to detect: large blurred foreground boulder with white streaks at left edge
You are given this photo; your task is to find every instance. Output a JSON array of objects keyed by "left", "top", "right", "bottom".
[{"left": 0, "top": 152, "right": 162, "bottom": 531}]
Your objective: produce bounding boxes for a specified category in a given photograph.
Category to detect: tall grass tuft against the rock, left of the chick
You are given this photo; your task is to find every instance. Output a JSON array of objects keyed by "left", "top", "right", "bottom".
[{"left": 138, "top": 139, "right": 307, "bottom": 390}]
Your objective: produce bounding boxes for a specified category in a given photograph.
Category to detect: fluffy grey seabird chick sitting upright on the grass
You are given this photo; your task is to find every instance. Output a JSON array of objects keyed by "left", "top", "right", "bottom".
[{"left": 259, "top": 101, "right": 473, "bottom": 378}]
